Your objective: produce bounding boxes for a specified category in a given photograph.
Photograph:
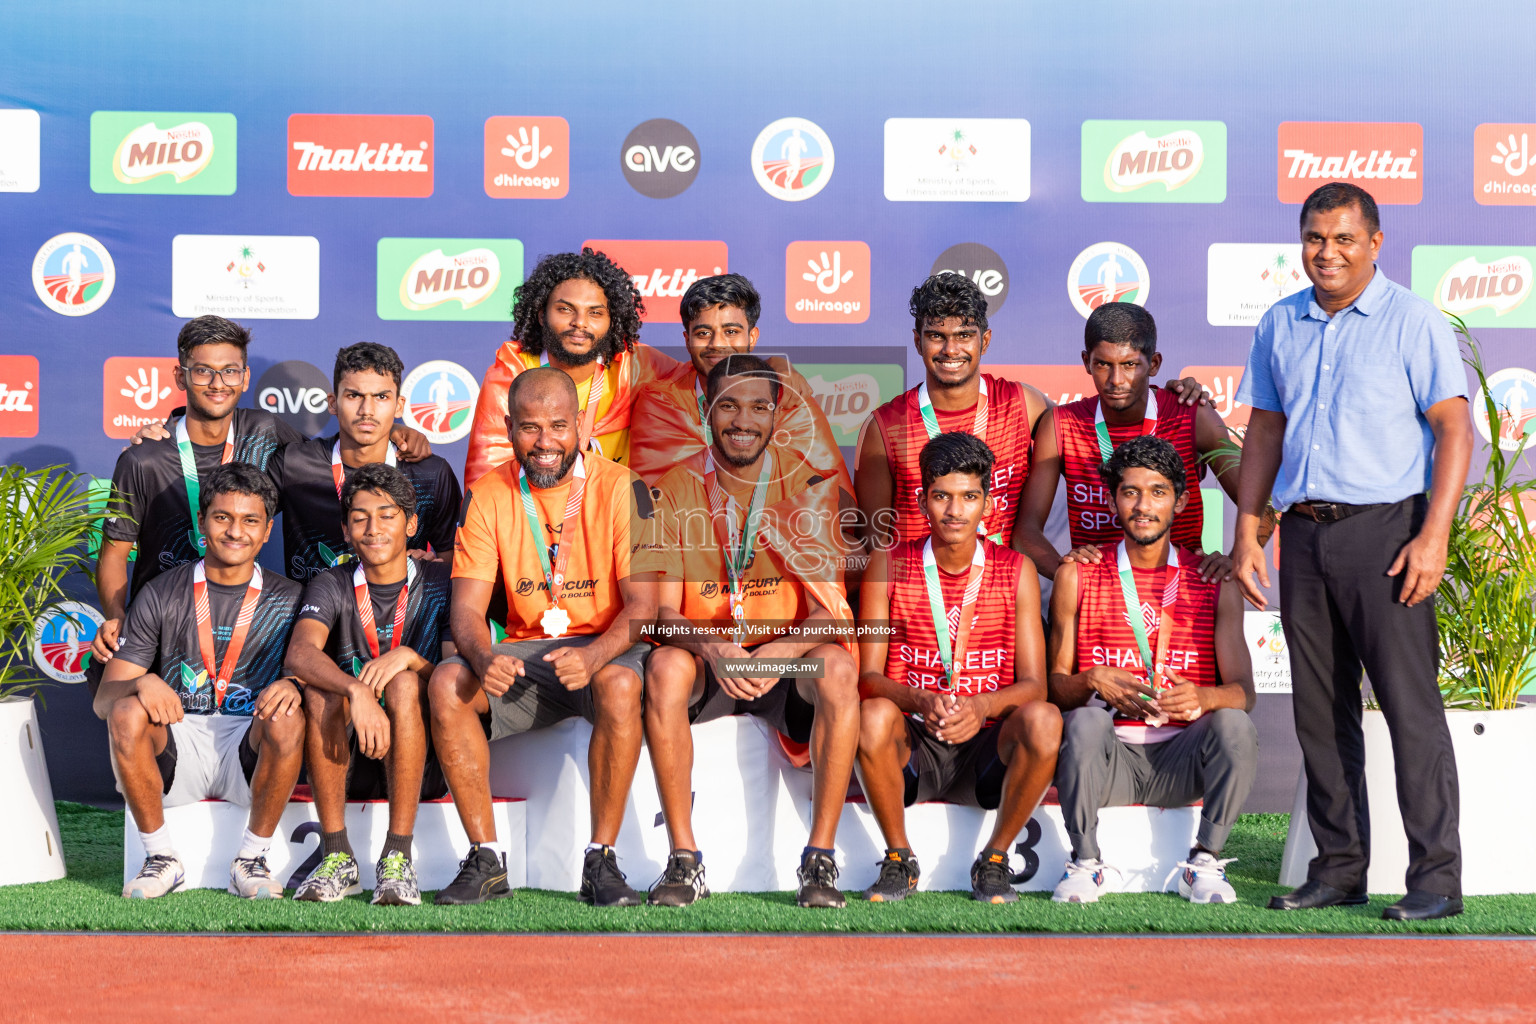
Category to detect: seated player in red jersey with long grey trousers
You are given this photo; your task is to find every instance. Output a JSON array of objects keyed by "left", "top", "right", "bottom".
[{"left": 1051, "top": 438, "right": 1258, "bottom": 903}]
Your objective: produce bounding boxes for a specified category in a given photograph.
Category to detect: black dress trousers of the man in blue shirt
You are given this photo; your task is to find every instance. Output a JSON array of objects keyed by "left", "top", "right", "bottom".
[{"left": 1279, "top": 496, "right": 1461, "bottom": 897}]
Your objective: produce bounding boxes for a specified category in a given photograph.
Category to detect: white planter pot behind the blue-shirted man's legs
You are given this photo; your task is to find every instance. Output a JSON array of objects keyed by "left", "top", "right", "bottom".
[{"left": 1279, "top": 705, "right": 1536, "bottom": 897}]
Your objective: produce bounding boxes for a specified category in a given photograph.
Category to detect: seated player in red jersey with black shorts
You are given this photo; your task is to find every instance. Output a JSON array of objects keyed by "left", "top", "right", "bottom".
[{"left": 859, "top": 431, "right": 1061, "bottom": 903}]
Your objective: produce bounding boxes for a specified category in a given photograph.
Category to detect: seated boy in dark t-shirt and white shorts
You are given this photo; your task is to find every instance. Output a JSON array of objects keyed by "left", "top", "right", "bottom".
[{"left": 92, "top": 462, "right": 304, "bottom": 900}]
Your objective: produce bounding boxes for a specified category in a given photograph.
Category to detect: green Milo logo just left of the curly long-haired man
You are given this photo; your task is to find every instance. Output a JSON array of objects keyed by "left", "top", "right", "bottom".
[{"left": 378, "top": 238, "right": 522, "bottom": 321}]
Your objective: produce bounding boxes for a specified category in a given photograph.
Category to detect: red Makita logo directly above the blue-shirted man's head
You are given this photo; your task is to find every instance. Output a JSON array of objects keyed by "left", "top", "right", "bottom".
[{"left": 1278, "top": 121, "right": 1424, "bottom": 203}]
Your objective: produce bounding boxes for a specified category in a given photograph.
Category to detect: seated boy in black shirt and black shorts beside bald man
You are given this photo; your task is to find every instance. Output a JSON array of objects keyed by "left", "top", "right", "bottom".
[{"left": 287, "top": 462, "right": 453, "bottom": 906}]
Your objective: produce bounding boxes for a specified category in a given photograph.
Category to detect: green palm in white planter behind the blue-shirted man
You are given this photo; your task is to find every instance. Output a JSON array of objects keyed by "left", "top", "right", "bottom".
[{"left": 1279, "top": 316, "right": 1536, "bottom": 895}]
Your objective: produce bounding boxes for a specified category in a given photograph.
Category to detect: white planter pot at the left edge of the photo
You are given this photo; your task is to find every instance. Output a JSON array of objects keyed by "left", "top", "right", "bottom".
[{"left": 0, "top": 697, "right": 65, "bottom": 886}]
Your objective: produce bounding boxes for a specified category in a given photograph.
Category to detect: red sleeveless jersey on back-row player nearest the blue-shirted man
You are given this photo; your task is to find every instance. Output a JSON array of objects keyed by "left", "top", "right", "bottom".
[{"left": 1055, "top": 387, "right": 1206, "bottom": 551}]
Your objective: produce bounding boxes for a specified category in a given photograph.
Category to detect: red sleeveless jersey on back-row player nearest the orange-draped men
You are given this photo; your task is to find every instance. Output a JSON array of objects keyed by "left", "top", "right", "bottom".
[{"left": 874, "top": 373, "right": 1034, "bottom": 549}]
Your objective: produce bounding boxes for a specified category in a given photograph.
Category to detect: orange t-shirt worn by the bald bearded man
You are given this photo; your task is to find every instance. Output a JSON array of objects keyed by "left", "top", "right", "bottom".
[{"left": 453, "top": 457, "right": 662, "bottom": 642}]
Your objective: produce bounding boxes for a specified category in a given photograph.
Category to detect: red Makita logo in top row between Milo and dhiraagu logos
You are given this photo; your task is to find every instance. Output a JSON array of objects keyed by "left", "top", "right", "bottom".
[{"left": 289, "top": 114, "right": 433, "bottom": 198}]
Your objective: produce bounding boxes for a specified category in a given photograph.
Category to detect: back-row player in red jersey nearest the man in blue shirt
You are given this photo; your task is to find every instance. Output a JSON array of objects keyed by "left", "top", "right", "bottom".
[{"left": 1012, "top": 302, "right": 1269, "bottom": 579}]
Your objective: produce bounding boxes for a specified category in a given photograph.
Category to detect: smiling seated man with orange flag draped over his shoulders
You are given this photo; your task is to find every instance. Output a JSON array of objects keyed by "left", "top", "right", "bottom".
[{"left": 645, "top": 355, "right": 859, "bottom": 907}]
